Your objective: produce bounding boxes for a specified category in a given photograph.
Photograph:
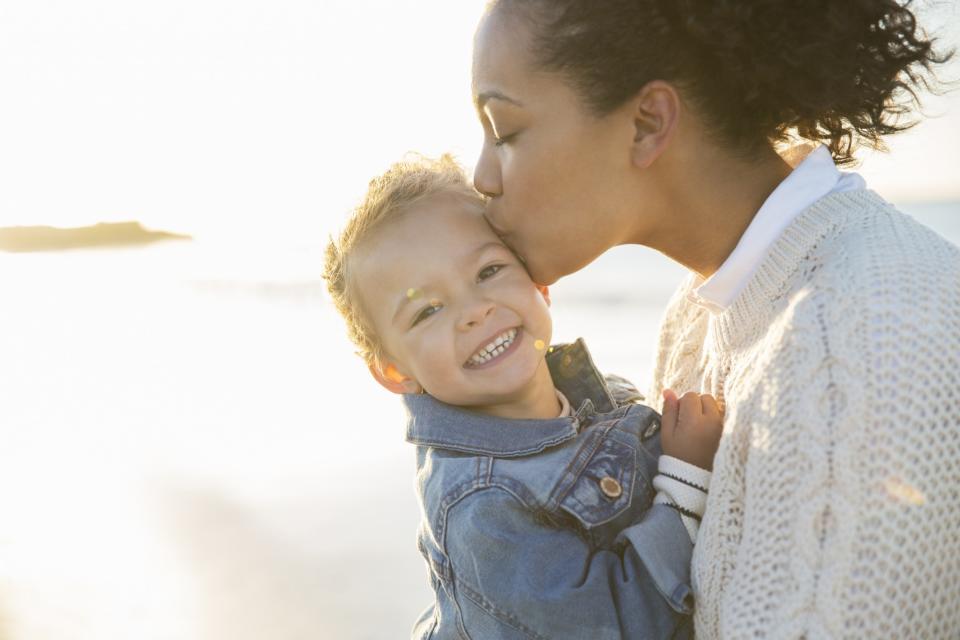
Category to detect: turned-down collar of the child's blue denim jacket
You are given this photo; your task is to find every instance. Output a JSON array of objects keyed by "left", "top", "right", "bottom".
[{"left": 403, "top": 338, "right": 617, "bottom": 457}]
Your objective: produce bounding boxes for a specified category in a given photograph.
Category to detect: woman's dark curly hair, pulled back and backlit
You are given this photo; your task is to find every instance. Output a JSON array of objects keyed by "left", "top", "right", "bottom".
[{"left": 489, "top": 0, "right": 953, "bottom": 164}]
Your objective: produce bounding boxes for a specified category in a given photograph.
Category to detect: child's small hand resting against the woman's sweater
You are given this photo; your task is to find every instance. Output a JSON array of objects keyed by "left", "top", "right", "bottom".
[{"left": 660, "top": 389, "right": 723, "bottom": 471}]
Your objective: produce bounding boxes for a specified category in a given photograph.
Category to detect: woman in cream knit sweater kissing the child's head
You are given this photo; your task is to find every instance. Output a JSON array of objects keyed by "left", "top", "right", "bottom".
[{"left": 473, "top": 0, "right": 960, "bottom": 638}]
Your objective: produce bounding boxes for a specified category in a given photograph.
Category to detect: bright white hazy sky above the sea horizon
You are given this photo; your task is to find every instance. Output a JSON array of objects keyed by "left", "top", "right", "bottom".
[{"left": 0, "top": 0, "right": 960, "bottom": 241}]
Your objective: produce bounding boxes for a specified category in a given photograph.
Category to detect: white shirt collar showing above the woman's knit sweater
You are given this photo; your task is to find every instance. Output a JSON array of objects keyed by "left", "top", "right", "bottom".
[{"left": 689, "top": 146, "right": 866, "bottom": 313}]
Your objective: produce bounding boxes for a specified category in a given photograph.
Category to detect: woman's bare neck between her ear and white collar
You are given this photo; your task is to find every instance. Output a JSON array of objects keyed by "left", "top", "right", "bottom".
[{"left": 639, "top": 137, "right": 792, "bottom": 278}]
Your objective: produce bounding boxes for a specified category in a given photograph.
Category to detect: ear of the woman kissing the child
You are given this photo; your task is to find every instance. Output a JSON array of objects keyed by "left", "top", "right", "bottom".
[{"left": 630, "top": 80, "right": 680, "bottom": 169}]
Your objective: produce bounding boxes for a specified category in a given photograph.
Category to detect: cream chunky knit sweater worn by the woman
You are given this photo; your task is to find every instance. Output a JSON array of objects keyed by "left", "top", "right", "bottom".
[{"left": 650, "top": 191, "right": 960, "bottom": 640}]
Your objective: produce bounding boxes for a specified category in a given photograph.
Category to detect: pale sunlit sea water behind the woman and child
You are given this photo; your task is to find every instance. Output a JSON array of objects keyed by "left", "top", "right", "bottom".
[{"left": 0, "top": 202, "right": 960, "bottom": 640}]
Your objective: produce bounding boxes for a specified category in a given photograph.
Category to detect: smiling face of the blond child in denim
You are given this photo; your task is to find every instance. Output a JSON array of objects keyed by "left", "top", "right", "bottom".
[{"left": 354, "top": 194, "right": 553, "bottom": 410}]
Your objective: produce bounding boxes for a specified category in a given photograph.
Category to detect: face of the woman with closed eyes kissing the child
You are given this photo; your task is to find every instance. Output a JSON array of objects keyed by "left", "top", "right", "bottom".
[{"left": 473, "top": 11, "right": 634, "bottom": 284}]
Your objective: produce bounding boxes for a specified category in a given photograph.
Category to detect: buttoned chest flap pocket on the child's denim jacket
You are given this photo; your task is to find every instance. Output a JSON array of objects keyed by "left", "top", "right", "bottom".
[{"left": 560, "top": 430, "right": 637, "bottom": 529}]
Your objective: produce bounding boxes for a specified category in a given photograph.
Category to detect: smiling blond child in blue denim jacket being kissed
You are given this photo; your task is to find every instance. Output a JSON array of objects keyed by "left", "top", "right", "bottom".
[{"left": 325, "top": 157, "right": 722, "bottom": 640}]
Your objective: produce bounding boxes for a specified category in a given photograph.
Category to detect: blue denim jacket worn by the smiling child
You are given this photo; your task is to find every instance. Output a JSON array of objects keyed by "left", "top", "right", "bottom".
[{"left": 404, "top": 340, "right": 692, "bottom": 640}]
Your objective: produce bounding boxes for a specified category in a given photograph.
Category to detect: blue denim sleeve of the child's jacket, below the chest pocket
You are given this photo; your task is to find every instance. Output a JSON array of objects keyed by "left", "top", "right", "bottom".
[{"left": 443, "top": 487, "right": 692, "bottom": 640}]
